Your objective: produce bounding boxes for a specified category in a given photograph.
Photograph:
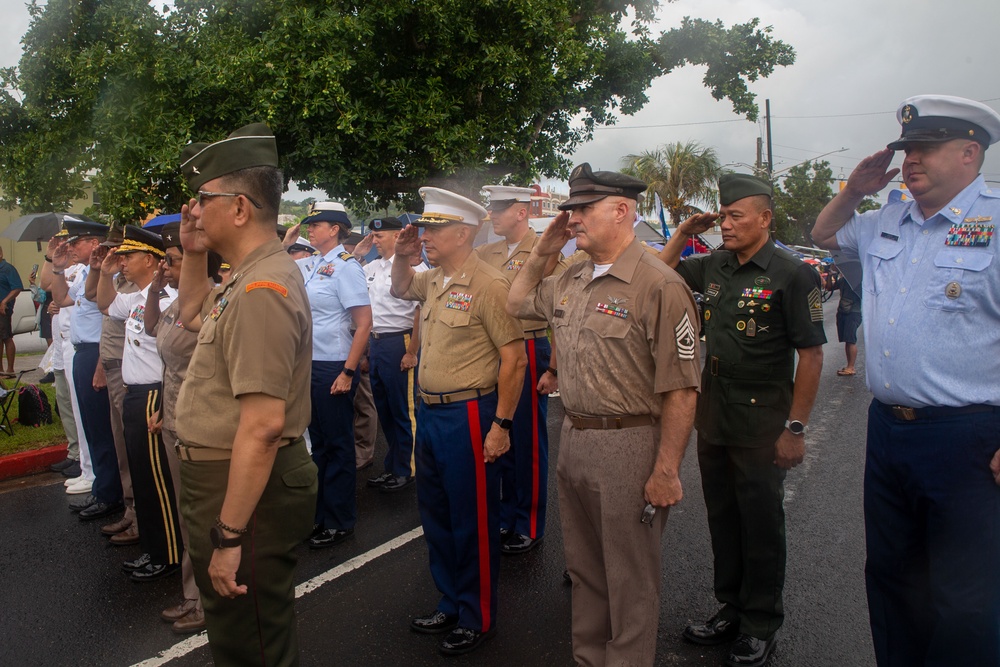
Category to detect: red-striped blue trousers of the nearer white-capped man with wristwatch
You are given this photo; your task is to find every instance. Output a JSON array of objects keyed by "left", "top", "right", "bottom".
[{"left": 416, "top": 392, "right": 500, "bottom": 632}]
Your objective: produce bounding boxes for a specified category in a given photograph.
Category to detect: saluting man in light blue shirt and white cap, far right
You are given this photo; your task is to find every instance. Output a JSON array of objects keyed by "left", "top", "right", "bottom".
[{"left": 813, "top": 95, "right": 1000, "bottom": 667}]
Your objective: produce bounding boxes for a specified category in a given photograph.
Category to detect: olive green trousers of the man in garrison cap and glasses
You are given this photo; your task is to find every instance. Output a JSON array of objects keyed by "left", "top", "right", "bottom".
[{"left": 180, "top": 439, "right": 317, "bottom": 667}]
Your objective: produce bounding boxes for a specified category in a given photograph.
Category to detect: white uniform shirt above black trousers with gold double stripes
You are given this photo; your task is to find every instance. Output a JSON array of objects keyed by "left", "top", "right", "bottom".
[{"left": 108, "top": 285, "right": 177, "bottom": 385}]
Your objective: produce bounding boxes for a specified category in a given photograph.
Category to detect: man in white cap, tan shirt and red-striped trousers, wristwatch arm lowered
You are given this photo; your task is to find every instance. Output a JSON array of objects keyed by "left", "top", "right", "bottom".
[{"left": 391, "top": 188, "right": 527, "bottom": 655}]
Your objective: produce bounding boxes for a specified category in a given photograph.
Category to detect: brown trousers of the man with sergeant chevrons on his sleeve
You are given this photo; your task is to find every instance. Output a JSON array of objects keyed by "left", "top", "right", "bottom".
[{"left": 556, "top": 419, "right": 667, "bottom": 667}]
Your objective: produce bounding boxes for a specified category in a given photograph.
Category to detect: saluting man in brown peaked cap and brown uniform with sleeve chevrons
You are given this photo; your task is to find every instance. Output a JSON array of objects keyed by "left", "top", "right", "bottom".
[{"left": 507, "top": 163, "right": 699, "bottom": 667}]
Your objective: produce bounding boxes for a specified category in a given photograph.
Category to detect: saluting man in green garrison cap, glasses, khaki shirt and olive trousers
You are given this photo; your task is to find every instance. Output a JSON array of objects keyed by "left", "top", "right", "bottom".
[{"left": 171, "top": 123, "right": 317, "bottom": 665}]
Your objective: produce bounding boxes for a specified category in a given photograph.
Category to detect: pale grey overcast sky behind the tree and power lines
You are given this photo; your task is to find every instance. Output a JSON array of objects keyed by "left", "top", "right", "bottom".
[{"left": 0, "top": 0, "right": 1000, "bottom": 198}]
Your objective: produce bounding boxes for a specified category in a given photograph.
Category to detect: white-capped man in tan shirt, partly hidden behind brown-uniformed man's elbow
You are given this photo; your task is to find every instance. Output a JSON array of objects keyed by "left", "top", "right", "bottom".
[{"left": 476, "top": 185, "right": 565, "bottom": 554}]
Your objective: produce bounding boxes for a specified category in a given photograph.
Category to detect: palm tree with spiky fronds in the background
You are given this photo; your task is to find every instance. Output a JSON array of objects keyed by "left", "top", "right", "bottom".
[{"left": 622, "top": 141, "right": 722, "bottom": 226}]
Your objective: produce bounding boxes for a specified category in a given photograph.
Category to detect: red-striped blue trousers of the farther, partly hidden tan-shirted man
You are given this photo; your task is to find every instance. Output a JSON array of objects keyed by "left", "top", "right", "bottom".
[{"left": 499, "top": 338, "right": 552, "bottom": 539}]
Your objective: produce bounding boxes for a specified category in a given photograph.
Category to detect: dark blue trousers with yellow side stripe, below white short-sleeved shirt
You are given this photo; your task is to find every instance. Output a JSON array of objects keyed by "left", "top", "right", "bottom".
[{"left": 369, "top": 334, "right": 417, "bottom": 477}]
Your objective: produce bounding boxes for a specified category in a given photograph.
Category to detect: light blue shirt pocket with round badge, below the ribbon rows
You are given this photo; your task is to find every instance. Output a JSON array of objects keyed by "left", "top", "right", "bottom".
[{"left": 924, "top": 248, "right": 993, "bottom": 312}]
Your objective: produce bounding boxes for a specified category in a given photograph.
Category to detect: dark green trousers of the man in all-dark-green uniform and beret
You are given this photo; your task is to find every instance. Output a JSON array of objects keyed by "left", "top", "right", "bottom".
[{"left": 698, "top": 437, "right": 785, "bottom": 639}]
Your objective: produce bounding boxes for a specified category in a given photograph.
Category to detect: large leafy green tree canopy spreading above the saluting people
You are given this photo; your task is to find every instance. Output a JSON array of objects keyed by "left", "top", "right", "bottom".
[{"left": 0, "top": 0, "right": 794, "bottom": 221}]
